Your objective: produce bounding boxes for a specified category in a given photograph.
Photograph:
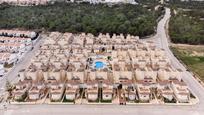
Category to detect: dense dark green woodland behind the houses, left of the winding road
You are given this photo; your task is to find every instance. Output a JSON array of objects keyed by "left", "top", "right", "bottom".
[{"left": 0, "top": 3, "right": 161, "bottom": 37}]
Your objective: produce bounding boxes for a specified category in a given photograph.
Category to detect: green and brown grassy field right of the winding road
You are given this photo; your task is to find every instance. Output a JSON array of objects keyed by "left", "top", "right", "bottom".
[{"left": 171, "top": 46, "right": 204, "bottom": 81}]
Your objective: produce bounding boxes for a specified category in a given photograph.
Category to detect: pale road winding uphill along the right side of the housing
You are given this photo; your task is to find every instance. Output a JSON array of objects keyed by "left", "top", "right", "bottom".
[{"left": 156, "top": 8, "right": 204, "bottom": 108}]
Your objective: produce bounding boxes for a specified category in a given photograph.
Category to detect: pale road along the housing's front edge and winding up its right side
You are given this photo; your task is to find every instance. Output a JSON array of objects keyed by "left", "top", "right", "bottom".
[{"left": 0, "top": 8, "right": 204, "bottom": 115}]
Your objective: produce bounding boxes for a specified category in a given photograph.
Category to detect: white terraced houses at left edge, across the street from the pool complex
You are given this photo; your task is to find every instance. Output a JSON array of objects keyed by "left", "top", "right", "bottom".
[{"left": 0, "top": 30, "right": 37, "bottom": 76}]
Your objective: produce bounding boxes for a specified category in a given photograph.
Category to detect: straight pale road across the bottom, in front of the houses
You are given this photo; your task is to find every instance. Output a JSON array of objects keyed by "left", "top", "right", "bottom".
[{"left": 0, "top": 105, "right": 204, "bottom": 115}]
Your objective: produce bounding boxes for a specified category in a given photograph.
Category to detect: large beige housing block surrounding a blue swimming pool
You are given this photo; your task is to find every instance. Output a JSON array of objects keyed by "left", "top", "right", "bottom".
[{"left": 12, "top": 32, "right": 195, "bottom": 104}]
